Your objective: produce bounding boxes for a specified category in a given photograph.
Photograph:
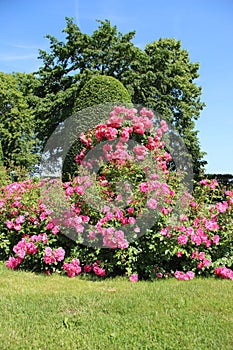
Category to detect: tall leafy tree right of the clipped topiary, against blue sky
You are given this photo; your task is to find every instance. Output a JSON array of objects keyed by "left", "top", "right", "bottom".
[{"left": 127, "top": 39, "right": 206, "bottom": 173}]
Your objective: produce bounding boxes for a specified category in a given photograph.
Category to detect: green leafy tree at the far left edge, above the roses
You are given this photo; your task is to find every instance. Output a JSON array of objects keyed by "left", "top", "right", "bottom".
[{"left": 0, "top": 73, "right": 37, "bottom": 169}]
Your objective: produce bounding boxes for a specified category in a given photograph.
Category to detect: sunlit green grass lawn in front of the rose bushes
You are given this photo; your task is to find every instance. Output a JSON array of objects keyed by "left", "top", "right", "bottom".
[{"left": 0, "top": 264, "right": 233, "bottom": 350}]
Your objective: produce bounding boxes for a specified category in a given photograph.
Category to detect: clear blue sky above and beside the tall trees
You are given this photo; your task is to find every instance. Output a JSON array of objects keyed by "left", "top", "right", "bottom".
[{"left": 0, "top": 0, "right": 233, "bottom": 174}]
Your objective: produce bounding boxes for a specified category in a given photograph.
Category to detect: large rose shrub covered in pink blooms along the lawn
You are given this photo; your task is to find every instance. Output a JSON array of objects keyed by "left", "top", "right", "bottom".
[{"left": 0, "top": 107, "right": 233, "bottom": 282}]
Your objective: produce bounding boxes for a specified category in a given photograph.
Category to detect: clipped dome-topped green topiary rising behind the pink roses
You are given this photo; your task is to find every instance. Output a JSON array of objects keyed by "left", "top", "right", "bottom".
[{"left": 62, "top": 75, "right": 132, "bottom": 181}]
